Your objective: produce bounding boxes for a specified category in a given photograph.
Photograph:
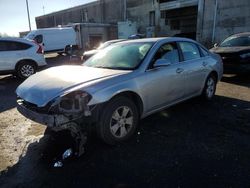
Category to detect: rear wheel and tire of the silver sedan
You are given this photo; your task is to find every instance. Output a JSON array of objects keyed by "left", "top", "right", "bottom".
[{"left": 202, "top": 74, "right": 217, "bottom": 100}]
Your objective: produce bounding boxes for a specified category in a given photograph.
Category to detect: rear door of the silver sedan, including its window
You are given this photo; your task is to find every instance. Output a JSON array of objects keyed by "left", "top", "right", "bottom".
[{"left": 178, "top": 41, "right": 208, "bottom": 97}]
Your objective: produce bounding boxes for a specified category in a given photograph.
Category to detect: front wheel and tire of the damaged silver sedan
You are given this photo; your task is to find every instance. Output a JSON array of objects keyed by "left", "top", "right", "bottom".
[{"left": 98, "top": 97, "right": 139, "bottom": 145}]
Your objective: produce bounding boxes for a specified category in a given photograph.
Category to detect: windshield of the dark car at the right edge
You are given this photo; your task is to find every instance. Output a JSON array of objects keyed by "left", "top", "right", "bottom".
[{"left": 220, "top": 36, "right": 250, "bottom": 47}]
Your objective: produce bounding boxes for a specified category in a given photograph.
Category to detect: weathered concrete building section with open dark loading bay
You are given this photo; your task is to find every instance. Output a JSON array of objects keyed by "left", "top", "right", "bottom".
[{"left": 127, "top": 0, "right": 250, "bottom": 47}]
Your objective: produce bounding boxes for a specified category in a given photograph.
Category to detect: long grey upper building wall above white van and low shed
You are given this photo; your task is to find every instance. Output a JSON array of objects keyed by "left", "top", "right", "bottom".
[{"left": 36, "top": 0, "right": 125, "bottom": 28}]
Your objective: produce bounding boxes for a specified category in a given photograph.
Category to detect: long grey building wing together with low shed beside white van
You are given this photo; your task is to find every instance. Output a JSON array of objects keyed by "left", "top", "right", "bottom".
[{"left": 36, "top": 0, "right": 125, "bottom": 49}]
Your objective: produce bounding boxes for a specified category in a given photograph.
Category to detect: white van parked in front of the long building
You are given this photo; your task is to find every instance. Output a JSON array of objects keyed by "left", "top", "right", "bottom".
[{"left": 25, "top": 27, "right": 77, "bottom": 53}]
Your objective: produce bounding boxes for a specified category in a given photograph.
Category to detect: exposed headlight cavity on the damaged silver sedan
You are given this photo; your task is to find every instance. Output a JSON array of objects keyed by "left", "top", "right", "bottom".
[{"left": 49, "top": 91, "right": 91, "bottom": 115}]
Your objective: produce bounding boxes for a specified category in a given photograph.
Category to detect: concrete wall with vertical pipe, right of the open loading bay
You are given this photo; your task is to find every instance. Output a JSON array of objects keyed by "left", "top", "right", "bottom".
[{"left": 196, "top": 0, "right": 250, "bottom": 46}]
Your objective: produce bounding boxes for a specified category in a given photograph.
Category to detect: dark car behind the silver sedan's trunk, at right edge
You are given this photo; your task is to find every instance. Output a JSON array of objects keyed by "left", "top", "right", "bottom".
[{"left": 210, "top": 32, "right": 250, "bottom": 73}]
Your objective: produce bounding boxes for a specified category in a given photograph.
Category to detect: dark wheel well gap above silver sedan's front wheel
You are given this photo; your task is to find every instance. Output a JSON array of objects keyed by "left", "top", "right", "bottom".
[{"left": 111, "top": 91, "right": 143, "bottom": 116}]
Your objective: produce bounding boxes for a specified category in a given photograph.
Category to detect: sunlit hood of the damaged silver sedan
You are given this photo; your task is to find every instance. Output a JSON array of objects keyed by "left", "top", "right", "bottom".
[{"left": 16, "top": 65, "right": 130, "bottom": 107}]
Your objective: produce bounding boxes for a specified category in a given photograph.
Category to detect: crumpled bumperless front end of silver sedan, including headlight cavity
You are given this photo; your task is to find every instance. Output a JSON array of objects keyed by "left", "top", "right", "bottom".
[{"left": 17, "top": 91, "right": 91, "bottom": 128}]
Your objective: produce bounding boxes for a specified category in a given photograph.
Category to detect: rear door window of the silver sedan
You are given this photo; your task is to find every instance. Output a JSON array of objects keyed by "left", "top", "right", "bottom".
[{"left": 179, "top": 42, "right": 201, "bottom": 61}]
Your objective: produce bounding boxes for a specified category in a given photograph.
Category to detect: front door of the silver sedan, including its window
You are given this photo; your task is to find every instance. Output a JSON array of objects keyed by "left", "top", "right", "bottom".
[{"left": 142, "top": 43, "right": 185, "bottom": 113}]
